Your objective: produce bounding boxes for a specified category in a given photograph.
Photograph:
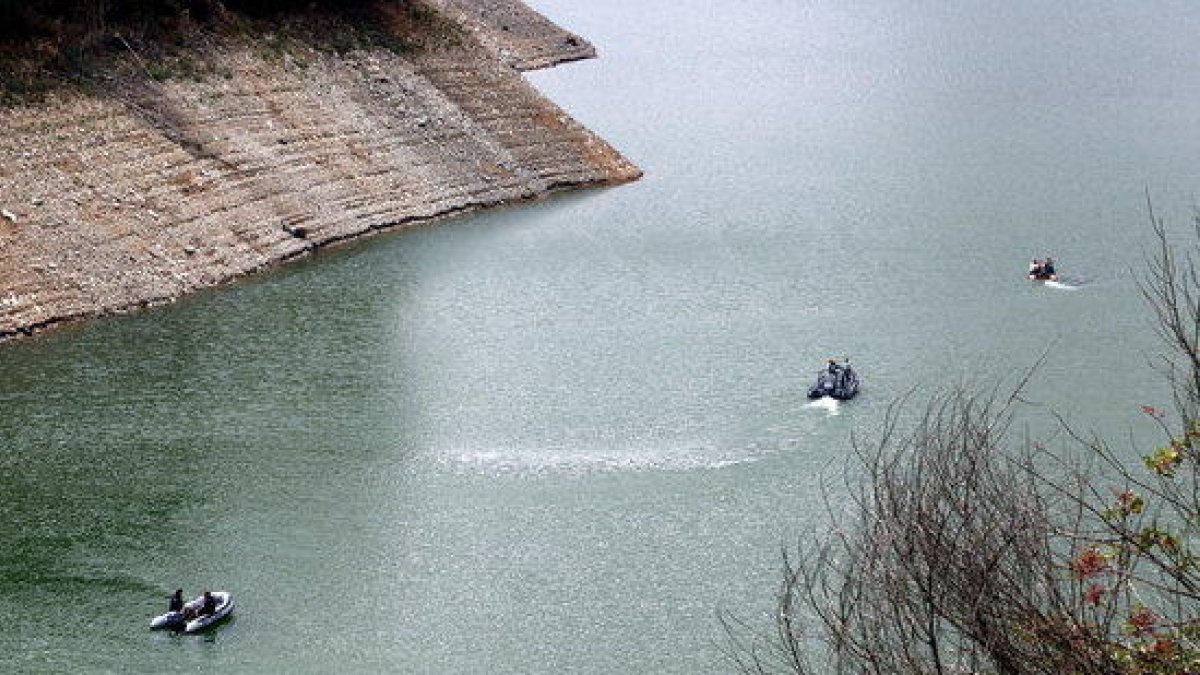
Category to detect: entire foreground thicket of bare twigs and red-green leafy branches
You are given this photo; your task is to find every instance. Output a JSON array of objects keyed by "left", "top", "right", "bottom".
[{"left": 724, "top": 211, "right": 1200, "bottom": 675}]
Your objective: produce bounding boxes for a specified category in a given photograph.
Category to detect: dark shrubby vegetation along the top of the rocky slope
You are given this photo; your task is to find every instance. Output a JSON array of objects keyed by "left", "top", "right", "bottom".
[{"left": 0, "top": 0, "right": 462, "bottom": 106}]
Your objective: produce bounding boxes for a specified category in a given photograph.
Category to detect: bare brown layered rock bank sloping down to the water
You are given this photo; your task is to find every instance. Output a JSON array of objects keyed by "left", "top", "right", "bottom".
[{"left": 0, "top": 0, "right": 640, "bottom": 339}]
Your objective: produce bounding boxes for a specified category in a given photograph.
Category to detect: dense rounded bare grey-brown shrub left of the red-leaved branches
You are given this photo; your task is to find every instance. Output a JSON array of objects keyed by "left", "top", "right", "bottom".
[{"left": 727, "top": 381, "right": 1116, "bottom": 674}]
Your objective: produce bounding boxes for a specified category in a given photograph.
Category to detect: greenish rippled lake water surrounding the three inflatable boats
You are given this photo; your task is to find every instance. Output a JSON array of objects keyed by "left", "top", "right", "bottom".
[{"left": 0, "top": 0, "right": 1200, "bottom": 674}]
